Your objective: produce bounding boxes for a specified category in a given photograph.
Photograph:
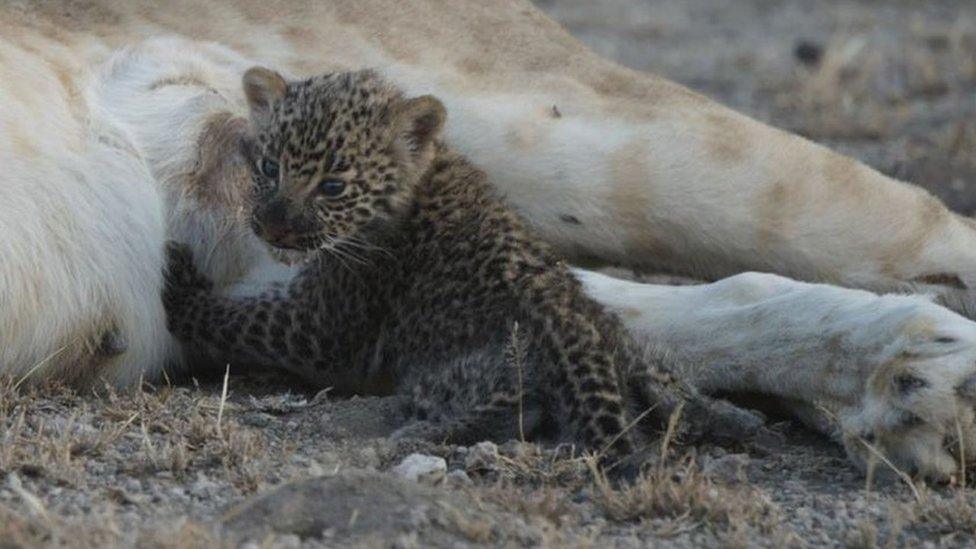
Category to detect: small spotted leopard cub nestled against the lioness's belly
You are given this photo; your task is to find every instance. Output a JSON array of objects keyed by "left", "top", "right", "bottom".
[{"left": 164, "top": 68, "right": 748, "bottom": 459}]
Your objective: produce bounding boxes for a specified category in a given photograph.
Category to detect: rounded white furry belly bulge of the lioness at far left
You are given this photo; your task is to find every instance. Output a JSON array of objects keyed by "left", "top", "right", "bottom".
[{"left": 0, "top": 37, "right": 172, "bottom": 384}]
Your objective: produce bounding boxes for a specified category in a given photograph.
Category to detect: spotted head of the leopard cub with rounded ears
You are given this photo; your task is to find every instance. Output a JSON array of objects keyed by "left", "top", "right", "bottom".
[{"left": 244, "top": 67, "right": 446, "bottom": 250}]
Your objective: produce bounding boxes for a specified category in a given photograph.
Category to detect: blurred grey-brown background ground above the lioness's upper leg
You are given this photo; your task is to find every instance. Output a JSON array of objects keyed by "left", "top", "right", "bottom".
[{"left": 535, "top": 0, "right": 976, "bottom": 215}]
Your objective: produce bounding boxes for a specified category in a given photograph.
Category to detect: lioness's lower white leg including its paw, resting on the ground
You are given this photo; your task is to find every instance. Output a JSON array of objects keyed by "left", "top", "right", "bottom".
[{"left": 577, "top": 271, "right": 976, "bottom": 477}]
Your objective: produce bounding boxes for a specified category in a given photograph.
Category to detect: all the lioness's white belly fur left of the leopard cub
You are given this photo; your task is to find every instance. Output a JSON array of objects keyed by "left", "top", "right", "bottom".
[{"left": 0, "top": 39, "right": 288, "bottom": 386}]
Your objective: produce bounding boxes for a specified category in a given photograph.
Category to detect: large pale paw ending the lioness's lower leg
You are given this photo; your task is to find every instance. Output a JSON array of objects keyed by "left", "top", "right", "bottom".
[{"left": 838, "top": 298, "right": 976, "bottom": 480}]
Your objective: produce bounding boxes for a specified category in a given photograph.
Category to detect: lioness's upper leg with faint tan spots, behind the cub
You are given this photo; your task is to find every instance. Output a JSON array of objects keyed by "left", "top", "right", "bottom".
[{"left": 449, "top": 93, "right": 976, "bottom": 308}]
